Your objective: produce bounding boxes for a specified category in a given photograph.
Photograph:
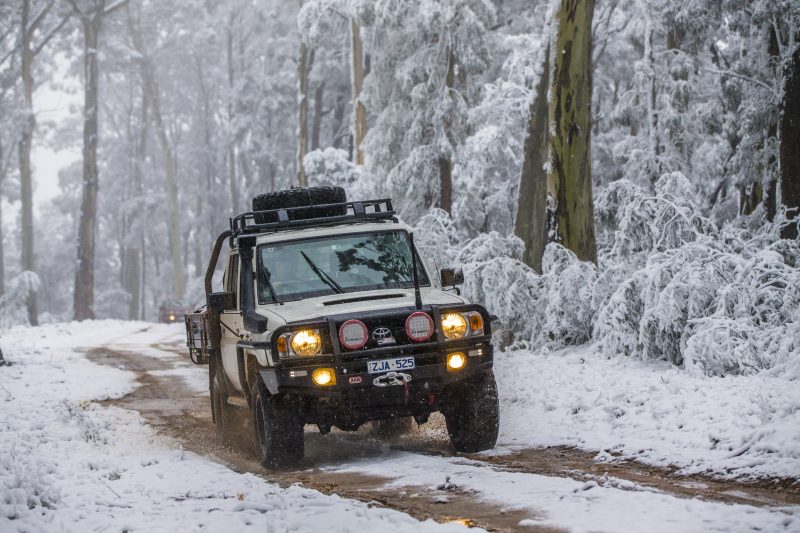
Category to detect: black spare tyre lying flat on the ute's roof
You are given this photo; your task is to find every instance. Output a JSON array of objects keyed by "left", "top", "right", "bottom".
[{"left": 253, "top": 187, "right": 347, "bottom": 224}]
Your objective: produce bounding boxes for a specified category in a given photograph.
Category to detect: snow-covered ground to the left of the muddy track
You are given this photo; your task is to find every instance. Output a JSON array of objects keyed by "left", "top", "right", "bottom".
[{"left": 0, "top": 321, "right": 472, "bottom": 532}]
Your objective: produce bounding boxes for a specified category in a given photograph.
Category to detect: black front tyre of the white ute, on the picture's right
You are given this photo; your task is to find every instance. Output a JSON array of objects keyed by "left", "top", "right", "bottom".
[{"left": 442, "top": 370, "right": 500, "bottom": 453}]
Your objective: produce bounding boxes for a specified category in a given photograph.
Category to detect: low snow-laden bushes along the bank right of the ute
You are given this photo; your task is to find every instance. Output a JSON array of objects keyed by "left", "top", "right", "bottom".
[{"left": 416, "top": 176, "right": 800, "bottom": 379}]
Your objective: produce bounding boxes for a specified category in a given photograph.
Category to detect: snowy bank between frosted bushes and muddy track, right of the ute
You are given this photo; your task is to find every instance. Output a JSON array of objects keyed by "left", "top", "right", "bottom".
[{"left": 495, "top": 347, "right": 800, "bottom": 479}]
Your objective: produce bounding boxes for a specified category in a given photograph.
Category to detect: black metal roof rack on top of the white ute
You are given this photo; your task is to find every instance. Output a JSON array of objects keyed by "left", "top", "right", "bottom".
[{"left": 230, "top": 198, "right": 397, "bottom": 238}]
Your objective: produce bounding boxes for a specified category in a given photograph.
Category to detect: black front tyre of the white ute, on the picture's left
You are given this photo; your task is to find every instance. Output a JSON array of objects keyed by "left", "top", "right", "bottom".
[{"left": 252, "top": 379, "right": 305, "bottom": 468}]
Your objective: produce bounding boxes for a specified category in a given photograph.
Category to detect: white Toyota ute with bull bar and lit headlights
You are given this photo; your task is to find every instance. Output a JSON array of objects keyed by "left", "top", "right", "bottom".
[{"left": 186, "top": 187, "right": 499, "bottom": 468}]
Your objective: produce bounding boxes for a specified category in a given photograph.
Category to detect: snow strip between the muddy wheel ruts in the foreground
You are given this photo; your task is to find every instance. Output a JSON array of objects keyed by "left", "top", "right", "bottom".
[{"left": 331, "top": 453, "right": 800, "bottom": 533}]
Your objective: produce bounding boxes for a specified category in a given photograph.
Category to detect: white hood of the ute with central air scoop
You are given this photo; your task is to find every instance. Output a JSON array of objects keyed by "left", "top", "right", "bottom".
[{"left": 256, "top": 287, "right": 466, "bottom": 329}]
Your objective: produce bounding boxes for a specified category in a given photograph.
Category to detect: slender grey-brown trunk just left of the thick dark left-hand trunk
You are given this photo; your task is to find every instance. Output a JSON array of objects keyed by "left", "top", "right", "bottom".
[{"left": 18, "top": 0, "right": 39, "bottom": 326}]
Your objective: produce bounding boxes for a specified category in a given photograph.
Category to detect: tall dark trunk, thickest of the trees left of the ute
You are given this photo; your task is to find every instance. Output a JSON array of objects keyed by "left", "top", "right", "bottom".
[{"left": 74, "top": 13, "right": 104, "bottom": 320}]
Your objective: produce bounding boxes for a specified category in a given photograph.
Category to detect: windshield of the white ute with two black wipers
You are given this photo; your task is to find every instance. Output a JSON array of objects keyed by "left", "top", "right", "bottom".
[{"left": 258, "top": 231, "right": 430, "bottom": 304}]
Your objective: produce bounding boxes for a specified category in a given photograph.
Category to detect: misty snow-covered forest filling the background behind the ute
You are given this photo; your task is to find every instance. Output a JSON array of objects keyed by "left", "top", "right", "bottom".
[{"left": 0, "top": 0, "right": 800, "bottom": 378}]
